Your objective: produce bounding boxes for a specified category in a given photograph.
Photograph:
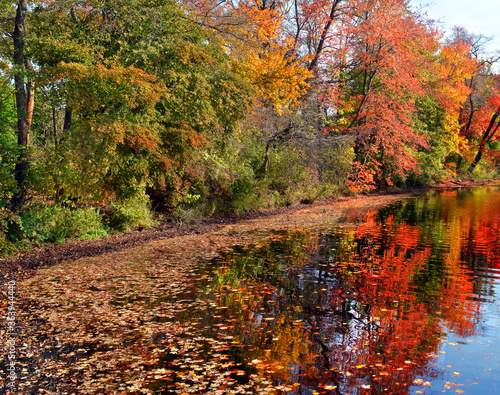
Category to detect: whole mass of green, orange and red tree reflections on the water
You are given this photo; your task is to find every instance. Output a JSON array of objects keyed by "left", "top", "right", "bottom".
[{"left": 214, "top": 191, "right": 500, "bottom": 393}]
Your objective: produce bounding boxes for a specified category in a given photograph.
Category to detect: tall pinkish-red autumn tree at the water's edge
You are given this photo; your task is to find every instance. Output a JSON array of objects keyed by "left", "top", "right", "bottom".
[{"left": 314, "top": 1, "right": 437, "bottom": 189}]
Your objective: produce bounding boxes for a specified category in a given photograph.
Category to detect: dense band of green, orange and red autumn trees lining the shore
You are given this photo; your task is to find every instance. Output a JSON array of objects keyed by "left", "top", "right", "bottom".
[{"left": 0, "top": 0, "right": 500, "bottom": 253}]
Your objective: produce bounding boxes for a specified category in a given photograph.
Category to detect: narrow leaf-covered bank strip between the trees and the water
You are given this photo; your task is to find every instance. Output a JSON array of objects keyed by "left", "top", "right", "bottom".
[{"left": 0, "top": 180, "right": 500, "bottom": 282}]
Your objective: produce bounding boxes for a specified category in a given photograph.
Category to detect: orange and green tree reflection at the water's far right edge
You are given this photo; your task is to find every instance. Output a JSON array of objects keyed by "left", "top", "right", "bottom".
[{"left": 379, "top": 188, "right": 500, "bottom": 295}]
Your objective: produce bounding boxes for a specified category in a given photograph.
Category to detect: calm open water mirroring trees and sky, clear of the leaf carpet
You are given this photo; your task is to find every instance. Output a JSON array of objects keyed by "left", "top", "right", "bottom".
[{"left": 172, "top": 188, "right": 500, "bottom": 395}]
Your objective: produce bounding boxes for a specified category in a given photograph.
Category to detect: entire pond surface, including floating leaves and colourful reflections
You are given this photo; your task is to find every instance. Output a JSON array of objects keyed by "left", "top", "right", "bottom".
[{"left": 4, "top": 187, "right": 500, "bottom": 395}]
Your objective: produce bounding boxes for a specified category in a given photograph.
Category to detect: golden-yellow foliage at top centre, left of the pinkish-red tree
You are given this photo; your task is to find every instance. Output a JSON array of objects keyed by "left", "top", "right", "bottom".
[{"left": 189, "top": 0, "right": 312, "bottom": 114}]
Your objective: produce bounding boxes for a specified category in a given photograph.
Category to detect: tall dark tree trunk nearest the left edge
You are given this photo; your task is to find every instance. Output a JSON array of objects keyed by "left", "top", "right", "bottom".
[{"left": 11, "top": 0, "right": 29, "bottom": 212}]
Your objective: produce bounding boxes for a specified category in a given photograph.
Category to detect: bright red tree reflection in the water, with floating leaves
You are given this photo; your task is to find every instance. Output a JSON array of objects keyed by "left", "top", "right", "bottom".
[{"left": 296, "top": 215, "right": 440, "bottom": 393}]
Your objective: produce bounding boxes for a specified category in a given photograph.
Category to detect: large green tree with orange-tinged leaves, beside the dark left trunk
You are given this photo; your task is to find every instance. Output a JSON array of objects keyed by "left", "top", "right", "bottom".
[{"left": 28, "top": 1, "right": 249, "bottom": 204}]
